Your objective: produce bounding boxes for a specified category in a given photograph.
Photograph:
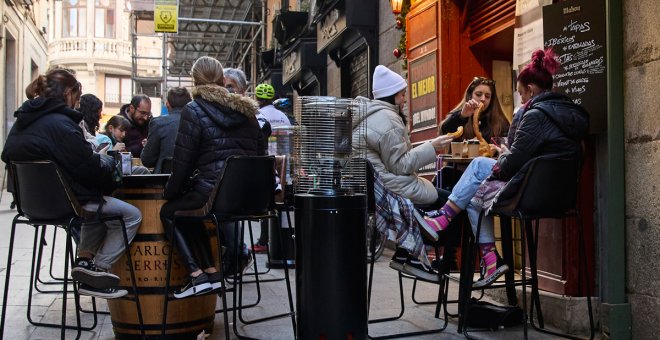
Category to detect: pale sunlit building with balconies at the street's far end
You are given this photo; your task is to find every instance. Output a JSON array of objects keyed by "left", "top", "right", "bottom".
[{"left": 48, "top": 0, "right": 163, "bottom": 115}]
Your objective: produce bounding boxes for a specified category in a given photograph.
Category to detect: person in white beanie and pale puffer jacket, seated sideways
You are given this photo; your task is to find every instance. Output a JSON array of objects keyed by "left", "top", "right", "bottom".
[{"left": 353, "top": 65, "right": 452, "bottom": 280}]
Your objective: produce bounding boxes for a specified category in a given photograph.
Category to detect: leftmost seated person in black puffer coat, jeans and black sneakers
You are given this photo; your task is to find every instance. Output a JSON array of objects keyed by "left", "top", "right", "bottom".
[{"left": 2, "top": 69, "right": 142, "bottom": 298}]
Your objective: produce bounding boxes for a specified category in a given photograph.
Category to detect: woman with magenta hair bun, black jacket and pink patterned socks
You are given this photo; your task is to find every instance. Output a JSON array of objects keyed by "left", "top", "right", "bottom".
[{"left": 420, "top": 49, "right": 589, "bottom": 288}]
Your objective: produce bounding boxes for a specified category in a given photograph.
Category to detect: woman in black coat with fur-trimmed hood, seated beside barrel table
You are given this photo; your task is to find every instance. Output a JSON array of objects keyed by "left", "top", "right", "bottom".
[{"left": 160, "top": 57, "right": 265, "bottom": 298}]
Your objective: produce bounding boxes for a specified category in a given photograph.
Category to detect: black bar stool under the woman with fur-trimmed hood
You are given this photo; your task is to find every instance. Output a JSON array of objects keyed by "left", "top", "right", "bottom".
[{"left": 161, "top": 156, "right": 296, "bottom": 339}]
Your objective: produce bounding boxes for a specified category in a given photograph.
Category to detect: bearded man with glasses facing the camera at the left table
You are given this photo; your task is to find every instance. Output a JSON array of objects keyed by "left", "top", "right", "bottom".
[{"left": 119, "top": 94, "right": 152, "bottom": 158}]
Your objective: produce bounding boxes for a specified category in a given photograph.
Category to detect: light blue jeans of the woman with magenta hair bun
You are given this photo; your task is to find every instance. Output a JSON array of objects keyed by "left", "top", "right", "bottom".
[{"left": 449, "top": 157, "right": 496, "bottom": 244}]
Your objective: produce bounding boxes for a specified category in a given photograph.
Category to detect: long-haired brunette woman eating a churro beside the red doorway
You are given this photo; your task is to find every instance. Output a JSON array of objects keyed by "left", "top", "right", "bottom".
[{"left": 440, "top": 77, "right": 509, "bottom": 142}]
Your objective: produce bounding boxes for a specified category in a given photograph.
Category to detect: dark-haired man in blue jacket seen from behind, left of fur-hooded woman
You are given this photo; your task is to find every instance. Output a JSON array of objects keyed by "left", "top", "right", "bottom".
[{"left": 140, "top": 87, "right": 192, "bottom": 174}]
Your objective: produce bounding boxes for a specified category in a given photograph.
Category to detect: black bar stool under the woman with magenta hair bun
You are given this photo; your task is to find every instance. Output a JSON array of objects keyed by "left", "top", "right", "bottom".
[{"left": 459, "top": 157, "right": 594, "bottom": 339}]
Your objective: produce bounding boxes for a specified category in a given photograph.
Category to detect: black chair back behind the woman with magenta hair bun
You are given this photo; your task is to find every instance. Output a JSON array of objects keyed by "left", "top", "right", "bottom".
[{"left": 506, "top": 158, "right": 580, "bottom": 217}]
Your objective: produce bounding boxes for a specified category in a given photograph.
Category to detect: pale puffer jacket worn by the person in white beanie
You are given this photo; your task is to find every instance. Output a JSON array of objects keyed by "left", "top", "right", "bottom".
[{"left": 353, "top": 97, "right": 438, "bottom": 204}]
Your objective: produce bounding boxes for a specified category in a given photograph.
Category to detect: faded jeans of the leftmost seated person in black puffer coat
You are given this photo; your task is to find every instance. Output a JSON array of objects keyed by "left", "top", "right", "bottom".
[{"left": 78, "top": 196, "right": 142, "bottom": 270}]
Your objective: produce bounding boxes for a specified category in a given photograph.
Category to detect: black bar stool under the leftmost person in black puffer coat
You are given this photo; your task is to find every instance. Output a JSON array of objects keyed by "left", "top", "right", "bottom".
[{"left": 0, "top": 161, "right": 144, "bottom": 339}]
